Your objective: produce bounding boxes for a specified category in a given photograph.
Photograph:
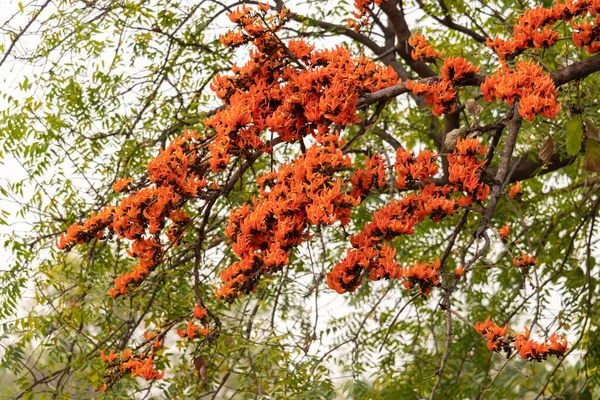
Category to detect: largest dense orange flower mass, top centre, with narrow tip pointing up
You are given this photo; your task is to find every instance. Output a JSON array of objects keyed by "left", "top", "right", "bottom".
[{"left": 205, "top": 7, "right": 398, "bottom": 172}]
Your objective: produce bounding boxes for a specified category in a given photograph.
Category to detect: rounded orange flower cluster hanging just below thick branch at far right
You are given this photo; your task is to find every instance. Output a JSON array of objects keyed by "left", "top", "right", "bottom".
[{"left": 481, "top": 61, "right": 560, "bottom": 121}]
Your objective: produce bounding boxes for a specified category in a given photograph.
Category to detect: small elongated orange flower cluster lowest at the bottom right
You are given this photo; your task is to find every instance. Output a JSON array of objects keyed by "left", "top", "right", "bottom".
[{"left": 475, "top": 317, "right": 569, "bottom": 362}]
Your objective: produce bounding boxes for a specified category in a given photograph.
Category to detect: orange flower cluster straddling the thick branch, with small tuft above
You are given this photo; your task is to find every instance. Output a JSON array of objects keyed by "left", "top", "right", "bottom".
[{"left": 406, "top": 43, "right": 479, "bottom": 115}]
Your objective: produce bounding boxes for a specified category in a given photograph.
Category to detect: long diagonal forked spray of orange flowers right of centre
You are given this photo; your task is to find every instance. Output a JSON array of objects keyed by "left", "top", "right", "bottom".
[{"left": 327, "top": 139, "right": 489, "bottom": 295}]
